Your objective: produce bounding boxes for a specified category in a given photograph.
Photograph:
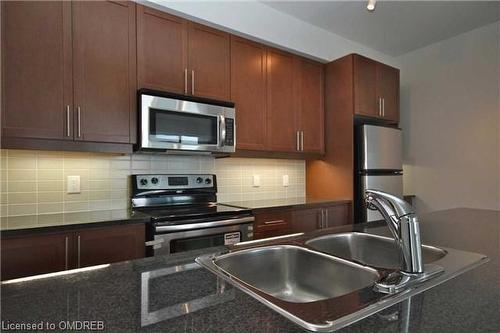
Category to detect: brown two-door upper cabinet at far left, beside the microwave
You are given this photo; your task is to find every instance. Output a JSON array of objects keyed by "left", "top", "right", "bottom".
[{"left": 2, "top": 1, "right": 136, "bottom": 151}]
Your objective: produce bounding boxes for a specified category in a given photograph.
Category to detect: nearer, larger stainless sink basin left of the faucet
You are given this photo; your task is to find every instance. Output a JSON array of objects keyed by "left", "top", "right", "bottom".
[{"left": 208, "top": 245, "right": 379, "bottom": 303}]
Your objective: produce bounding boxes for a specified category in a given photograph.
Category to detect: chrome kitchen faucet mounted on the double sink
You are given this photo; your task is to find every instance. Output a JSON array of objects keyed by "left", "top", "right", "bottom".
[{"left": 366, "top": 190, "right": 443, "bottom": 293}]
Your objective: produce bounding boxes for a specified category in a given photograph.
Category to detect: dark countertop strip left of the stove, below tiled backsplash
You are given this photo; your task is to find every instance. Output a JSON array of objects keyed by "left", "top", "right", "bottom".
[{"left": 1, "top": 209, "right": 151, "bottom": 237}]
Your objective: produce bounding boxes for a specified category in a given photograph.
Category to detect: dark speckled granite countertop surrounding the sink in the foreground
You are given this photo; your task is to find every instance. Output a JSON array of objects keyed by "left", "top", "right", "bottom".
[{"left": 1, "top": 209, "right": 500, "bottom": 333}]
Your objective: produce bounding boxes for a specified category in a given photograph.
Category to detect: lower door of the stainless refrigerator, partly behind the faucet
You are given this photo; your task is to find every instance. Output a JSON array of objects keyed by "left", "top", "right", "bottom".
[{"left": 361, "top": 175, "right": 403, "bottom": 222}]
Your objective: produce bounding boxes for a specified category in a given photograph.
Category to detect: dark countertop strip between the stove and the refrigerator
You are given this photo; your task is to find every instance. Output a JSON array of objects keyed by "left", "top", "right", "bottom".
[{"left": 222, "top": 197, "right": 351, "bottom": 209}]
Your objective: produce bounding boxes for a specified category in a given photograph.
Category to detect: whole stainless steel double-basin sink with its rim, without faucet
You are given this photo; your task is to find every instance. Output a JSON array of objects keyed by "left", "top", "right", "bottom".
[{"left": 197, "top": 232, "right": 486, "bottom": 332}]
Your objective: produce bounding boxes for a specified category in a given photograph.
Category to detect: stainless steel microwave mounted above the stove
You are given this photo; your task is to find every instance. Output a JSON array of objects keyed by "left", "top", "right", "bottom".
[{"left": 138, "top": 89, "right": 236, "bottom": 153}]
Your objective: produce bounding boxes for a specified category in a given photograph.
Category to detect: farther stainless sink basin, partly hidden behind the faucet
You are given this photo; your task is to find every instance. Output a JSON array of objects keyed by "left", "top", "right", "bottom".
[{"left": 306, "top": 232, "right": 446, "bottom": 269}]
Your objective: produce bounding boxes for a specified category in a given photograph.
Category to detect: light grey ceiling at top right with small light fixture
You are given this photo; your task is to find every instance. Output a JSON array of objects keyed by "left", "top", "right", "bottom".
[{"left": 262, "top": 1, "right": 500, "bottom": 56}]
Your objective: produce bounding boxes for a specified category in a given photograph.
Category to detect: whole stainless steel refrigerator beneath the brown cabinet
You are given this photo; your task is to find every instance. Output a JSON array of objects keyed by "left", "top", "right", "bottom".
[{"left": 354, "top": 124, "right": 403, "bottom": 223}]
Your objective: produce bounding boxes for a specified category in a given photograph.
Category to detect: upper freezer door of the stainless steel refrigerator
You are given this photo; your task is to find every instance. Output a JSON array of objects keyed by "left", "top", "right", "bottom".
[{"left": 361, "top": 125, "right": 403, "bottom": 170}]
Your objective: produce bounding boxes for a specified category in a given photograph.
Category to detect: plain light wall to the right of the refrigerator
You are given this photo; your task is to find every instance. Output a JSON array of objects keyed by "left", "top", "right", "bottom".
[{"left": 398, "top": 22, "right": 500, "bottom": 212}]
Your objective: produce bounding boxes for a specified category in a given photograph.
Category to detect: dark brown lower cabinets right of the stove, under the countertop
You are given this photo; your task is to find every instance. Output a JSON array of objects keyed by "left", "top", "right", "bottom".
[{"left": 254, "top": 203, "right": 352, "bottom": 239}]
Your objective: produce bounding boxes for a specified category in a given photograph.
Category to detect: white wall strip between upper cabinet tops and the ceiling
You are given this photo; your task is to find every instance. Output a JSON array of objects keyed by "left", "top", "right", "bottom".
[{"left": 144, "top": 0, "right": 397, "bottom": 66}]
